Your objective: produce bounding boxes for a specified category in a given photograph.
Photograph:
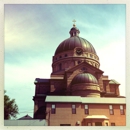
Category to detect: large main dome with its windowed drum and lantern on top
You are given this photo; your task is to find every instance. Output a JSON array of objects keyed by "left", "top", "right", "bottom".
[{"left": 52, "top": 25, "right": 100, "bottom": 74}]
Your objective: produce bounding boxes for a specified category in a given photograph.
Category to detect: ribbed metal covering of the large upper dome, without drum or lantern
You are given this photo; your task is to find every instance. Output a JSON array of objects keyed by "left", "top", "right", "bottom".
[{"left": 55, "top": 36, "right": 96, "bottom": 55}]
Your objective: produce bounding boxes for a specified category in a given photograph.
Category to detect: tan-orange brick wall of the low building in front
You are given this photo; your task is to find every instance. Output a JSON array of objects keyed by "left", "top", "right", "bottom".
[{"left": 46, "top": 103, "right": 126, "bottom": 126}]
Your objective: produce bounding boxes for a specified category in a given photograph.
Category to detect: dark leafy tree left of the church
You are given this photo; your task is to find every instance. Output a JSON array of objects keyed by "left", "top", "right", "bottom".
[{"left": 4, "top": 91, "right": 18, "bottom": 119}]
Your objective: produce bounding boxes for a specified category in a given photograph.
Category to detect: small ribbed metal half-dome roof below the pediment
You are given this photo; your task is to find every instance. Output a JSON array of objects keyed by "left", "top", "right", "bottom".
[{"left": 71, "top": 73, "right": 98, "bottom": 85}]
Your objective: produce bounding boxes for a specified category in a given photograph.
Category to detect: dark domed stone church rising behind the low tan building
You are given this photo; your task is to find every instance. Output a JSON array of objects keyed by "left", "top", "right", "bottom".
[{"left": 33, "top": 23, "right": 121, "bottom": 119}]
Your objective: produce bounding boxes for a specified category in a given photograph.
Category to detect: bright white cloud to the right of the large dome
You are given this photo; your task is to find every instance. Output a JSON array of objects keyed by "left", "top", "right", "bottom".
[{"left": 98, "top": 40, "right": 126, "bottom": 96}]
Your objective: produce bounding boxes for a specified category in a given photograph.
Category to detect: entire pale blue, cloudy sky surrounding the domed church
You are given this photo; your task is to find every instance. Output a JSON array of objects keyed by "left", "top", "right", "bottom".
[{"left": 4, "top": 4, "right": 126, "bottom": 118}]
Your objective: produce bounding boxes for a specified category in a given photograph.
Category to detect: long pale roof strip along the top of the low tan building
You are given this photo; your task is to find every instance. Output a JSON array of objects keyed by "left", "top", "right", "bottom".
[{"left": 45, "top": 96, "right": 126, "bottom": 104}]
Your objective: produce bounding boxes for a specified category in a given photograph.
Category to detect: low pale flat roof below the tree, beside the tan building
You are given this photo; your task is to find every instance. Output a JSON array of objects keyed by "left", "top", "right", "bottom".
[{"left": 4, "top": 120, "right": 47, "bottom": 126}]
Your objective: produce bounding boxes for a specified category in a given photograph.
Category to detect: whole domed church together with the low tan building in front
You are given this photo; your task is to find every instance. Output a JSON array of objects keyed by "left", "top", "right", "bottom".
[{"left": 33, "top": 23, "right": 126, "bottom": 126}]
